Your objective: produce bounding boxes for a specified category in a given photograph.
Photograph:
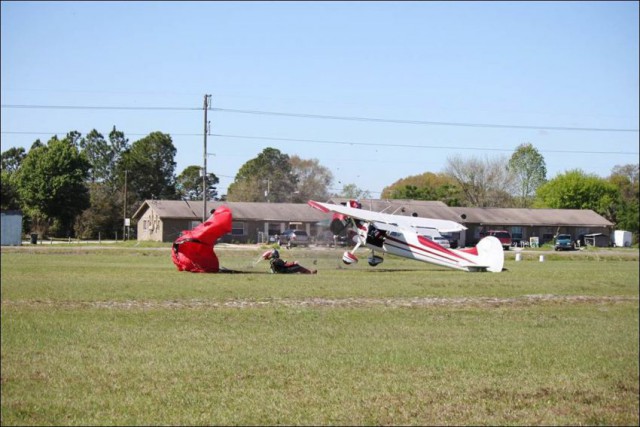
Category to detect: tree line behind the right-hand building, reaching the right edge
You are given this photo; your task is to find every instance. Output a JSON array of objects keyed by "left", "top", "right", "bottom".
[{"left": 382, "top": 143, "right": 640, "bottom": 242}]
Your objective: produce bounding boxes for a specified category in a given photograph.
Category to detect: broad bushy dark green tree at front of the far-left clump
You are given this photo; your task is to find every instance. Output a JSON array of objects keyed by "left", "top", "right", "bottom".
[{"left": 15, "top": 137, "right": 90, "bottom": 236}]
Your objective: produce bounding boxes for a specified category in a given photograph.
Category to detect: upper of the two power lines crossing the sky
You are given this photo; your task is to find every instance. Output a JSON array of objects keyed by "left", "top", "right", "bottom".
[{"left": 1, "top": 104, "right": 639, "bottom": 132}]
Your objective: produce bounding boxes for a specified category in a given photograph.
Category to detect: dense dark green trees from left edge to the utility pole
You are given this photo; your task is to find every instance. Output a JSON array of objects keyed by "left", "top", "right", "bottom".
[{"left": 1, "top": 126, "right": 218, "bottom": 238}]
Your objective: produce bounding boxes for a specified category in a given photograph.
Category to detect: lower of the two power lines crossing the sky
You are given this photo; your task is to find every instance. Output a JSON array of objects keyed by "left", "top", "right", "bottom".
[{"left": 0, "top": 131, "right": 638, "bottom": 155}]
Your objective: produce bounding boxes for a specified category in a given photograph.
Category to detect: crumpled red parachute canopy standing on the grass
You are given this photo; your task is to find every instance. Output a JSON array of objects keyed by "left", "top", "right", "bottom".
[{"left": 171, "top": 206, "right": 232, "bottom": 273}]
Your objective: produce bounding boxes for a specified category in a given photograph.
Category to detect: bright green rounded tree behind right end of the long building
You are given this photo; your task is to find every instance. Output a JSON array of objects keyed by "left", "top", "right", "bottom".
[{"left": 534, "top": 169, "right": 620, "bottom": 223}]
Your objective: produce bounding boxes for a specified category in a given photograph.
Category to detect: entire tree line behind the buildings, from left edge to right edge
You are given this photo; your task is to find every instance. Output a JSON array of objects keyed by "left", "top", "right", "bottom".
[{"left": 1, "top": 130, "right": 639, "bottom": 241}]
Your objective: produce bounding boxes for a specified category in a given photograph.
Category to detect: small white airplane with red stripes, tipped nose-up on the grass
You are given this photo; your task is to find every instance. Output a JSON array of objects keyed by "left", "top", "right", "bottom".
[{"left": 307, "top": 200, "right": 504, "bottom": 273}]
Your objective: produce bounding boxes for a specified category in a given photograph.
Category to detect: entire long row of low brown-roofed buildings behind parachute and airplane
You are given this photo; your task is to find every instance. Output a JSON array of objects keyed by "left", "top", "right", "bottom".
[{"left": 132, "top": 198, "right": 613, "bottom": 246}]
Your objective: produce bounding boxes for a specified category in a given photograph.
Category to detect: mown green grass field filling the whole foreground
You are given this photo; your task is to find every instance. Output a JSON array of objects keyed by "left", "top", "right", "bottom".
[{"left": 1, "top": 245, "right": 640, "bottom": 425}]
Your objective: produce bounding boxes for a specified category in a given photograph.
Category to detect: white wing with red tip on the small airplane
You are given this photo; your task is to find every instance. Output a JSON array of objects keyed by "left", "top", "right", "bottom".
[{"left": 308, "top": 200, "right": 467, "bottom": 233}]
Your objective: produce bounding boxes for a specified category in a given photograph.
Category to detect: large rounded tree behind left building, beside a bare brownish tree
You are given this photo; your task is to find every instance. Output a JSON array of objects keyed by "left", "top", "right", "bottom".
[{"left": 227, "top": 147, "right": 298, "bottom": 202}]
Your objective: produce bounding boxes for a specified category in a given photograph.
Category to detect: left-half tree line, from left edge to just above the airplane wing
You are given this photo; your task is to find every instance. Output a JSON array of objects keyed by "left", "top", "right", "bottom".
[{"left": 0, "top": 126, "right": 344, "bottom": 239}]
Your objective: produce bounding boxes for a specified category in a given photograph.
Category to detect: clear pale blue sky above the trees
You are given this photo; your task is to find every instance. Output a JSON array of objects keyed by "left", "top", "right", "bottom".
[{"left": 0, "top": 1, "right": 640, "bottom": 198}]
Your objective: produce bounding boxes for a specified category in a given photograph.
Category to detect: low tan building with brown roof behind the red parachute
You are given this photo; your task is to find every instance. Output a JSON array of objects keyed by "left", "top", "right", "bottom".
[{"left": 132, "top": 200, "right": 331, "bottom": 243}]
